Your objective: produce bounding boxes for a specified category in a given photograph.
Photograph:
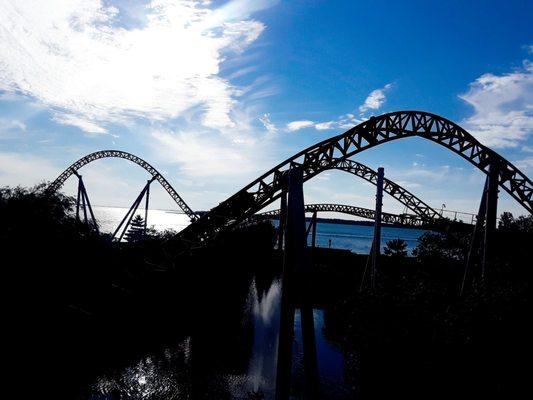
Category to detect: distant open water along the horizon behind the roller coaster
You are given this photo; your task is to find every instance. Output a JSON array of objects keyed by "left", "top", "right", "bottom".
[{"left": 90, "top": 207, "right": 425, "bottom": 254}]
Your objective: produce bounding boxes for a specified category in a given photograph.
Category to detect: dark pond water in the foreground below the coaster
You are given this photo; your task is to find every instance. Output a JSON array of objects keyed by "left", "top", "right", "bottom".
[{"left": 87, "top": 279, "right": 353, "bottom": 400}]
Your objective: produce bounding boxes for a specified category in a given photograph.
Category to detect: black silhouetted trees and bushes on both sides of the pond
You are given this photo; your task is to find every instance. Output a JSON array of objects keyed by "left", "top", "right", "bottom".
[{"left": 0, "top": 185, "right": 533, "bottom": 399}]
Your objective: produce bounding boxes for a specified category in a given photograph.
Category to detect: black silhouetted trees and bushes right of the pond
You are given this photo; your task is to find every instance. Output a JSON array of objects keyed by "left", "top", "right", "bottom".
[{"left": 314, "top": 220, "right": 533, "bottom": 399}]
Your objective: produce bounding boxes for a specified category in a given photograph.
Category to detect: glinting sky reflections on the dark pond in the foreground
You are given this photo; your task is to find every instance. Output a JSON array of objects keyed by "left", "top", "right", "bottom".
[{"left": 86, "top": 279, "right": 353, "bottom": 400}]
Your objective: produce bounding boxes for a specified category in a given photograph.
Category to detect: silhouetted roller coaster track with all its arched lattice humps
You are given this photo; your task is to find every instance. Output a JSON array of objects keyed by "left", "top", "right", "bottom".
[{"left": 49, "top": 111, "right": 533, "bottom": 242}]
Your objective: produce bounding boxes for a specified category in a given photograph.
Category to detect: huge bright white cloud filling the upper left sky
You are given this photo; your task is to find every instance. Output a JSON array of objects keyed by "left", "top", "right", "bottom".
[{"left": 0, "top": 0, "right": 276, "bottom": 133}]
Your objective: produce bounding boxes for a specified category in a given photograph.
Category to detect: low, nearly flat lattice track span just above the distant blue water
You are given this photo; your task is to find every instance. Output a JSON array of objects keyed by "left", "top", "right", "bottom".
[{"left": 257, "top": 204, "right": 425, "bottom": 227}]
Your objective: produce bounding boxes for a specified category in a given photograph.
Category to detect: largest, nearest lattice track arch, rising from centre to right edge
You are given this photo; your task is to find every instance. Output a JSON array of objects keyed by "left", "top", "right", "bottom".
[{"left": 177, "top": 111, "right": 533, "bottom": 241}]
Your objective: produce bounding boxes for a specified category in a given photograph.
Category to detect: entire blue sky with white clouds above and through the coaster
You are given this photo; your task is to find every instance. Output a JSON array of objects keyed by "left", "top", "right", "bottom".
[{"left": 0, "top": 0, "right": 533, "bottom": 219}]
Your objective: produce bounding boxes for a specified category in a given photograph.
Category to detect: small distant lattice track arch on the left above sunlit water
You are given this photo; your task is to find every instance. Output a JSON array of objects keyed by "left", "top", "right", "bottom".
[{"left": 47, "top": 150, "right": 198, "bottom": 221}]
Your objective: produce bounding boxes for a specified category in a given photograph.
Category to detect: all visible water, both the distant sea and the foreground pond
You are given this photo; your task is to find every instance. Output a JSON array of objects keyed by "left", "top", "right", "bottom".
[{"left": 81, "top": 207, "right": 424, "bottom": 400}]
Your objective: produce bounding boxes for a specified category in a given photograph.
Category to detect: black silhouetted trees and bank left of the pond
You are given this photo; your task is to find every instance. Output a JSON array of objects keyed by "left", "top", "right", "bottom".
[{"left": 4, "top": 185, "right": 281, "bottom": 398}]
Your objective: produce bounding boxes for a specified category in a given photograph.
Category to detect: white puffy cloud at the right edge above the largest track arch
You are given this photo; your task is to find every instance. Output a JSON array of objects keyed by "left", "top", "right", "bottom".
[{"left": 459, "top": 61, "right": 533, "bottom": 148}]
